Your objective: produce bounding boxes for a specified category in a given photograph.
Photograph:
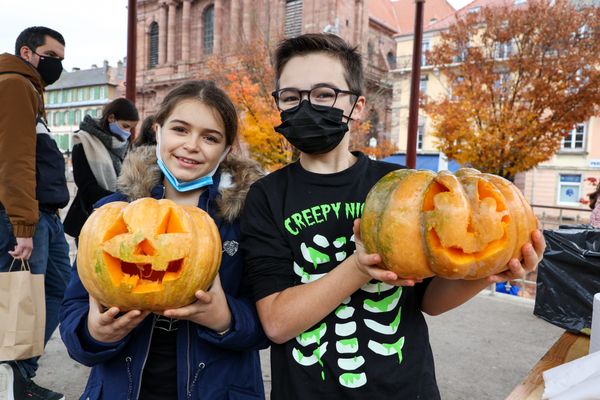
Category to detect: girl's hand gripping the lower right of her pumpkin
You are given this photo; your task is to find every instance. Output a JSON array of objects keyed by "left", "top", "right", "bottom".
[{"left": 163, "top": 275, "right": 231, "bottom": 332}]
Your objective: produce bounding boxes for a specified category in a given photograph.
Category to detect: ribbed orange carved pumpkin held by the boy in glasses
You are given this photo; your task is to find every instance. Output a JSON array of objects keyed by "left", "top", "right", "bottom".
[{"left": 360, "top": 168, "right": 537, "bottom": 279}]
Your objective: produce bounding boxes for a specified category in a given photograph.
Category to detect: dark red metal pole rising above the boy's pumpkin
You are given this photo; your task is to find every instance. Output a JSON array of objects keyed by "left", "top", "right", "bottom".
[{"left": 406, "top": 0, "right": 425, "bottom": 168}]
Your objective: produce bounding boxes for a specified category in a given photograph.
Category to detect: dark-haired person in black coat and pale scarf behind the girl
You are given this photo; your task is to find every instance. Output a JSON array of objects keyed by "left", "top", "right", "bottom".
[{"left": 64, "top": 98, "right": 140, "bottom": 238}]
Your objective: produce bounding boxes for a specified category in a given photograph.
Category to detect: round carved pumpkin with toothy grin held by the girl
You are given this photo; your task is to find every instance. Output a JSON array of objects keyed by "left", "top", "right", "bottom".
[{"left": 77, "top": 198, "right": 221, "bottom": 311}]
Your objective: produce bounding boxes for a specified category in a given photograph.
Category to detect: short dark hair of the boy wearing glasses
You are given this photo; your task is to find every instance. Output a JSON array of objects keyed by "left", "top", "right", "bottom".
[{"left": 275, "top": 33, "right": 364, "bottom": 95}]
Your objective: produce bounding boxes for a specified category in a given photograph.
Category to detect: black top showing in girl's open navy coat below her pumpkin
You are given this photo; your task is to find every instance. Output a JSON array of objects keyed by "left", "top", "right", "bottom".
[{"left": 139, "top": 316, "right": 179, "bottom": 400}]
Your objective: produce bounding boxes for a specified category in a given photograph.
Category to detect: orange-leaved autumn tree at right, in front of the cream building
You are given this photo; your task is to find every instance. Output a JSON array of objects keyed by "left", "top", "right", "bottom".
[{"left": 425, "top": 0, "right": 600, "bottom": 179}]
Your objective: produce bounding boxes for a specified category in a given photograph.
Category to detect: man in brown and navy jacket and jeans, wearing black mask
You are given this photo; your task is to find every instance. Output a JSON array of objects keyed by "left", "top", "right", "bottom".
[{"left": 0, "top": 26, "right": 71, "bottom": 400}]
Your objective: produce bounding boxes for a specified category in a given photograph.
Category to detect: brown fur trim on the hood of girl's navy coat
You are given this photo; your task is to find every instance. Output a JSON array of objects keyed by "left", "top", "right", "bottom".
[{"left": 117, "top": 146, "right": 264, "bottom": 222}]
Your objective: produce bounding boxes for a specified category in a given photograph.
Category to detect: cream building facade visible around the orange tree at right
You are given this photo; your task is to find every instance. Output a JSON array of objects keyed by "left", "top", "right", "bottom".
[{"left": 392, "top": 0, "right": 600, "bottom": 222}]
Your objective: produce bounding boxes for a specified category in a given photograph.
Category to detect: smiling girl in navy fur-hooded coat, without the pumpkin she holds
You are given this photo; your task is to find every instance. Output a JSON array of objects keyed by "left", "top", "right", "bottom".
[{"left": 60, "top": 81, "right": 268, "bottom": 400}]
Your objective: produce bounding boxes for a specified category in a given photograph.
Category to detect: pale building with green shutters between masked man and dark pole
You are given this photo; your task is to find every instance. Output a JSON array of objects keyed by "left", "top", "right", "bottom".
[{"left": 44, "top": 61, "right": 125, "bottom": 154}]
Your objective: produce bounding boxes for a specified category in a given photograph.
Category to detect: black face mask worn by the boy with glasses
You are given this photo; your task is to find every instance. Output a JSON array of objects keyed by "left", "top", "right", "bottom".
[{"left": 275, "top": 100, "right": 348, "bottom": 154}]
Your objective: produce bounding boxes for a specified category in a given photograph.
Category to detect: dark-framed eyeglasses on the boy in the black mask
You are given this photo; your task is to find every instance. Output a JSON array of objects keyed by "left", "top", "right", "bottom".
[{"left": 271, "top": 86, "right": 358, "bottom": 111}]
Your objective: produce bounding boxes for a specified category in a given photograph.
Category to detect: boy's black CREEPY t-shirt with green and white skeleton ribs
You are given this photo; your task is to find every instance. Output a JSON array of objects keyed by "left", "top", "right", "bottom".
[{"left": 242, "top": 153, "right": 439, "bottom": 400}]
